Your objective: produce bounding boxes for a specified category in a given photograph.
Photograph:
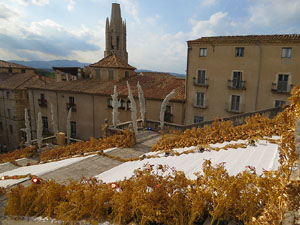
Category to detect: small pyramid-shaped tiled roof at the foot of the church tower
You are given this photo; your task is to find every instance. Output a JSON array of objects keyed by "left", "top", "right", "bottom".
[{"left": 90, "top": 54, "right": 136, "bottom": 70}]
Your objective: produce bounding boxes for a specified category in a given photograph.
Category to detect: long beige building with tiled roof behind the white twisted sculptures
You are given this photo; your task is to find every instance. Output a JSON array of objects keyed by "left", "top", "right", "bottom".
[{"left": 28, "top": 72, "right": 185, "bottom": 140}]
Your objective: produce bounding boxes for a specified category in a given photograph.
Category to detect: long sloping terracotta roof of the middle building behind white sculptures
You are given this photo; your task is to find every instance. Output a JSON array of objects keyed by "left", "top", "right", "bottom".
[{"left": 29, "top": 73, "right": 185, "bottom": 101}]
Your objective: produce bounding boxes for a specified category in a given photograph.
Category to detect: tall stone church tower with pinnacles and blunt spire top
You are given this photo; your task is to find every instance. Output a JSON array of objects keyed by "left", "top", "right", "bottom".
[{"left": 104, "top": 3, "right": 128, "bottom": 63}]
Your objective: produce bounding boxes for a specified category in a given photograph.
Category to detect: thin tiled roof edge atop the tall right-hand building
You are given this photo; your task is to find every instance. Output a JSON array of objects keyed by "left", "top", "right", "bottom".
[{"left": 188, "top": 34, "right": 300, "bottom": 43}]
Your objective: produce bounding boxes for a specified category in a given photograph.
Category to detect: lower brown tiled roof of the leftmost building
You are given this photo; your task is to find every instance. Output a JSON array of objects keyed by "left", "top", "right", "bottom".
[{"left": 0, "top": 73, "right": 55, "bottom": 90}]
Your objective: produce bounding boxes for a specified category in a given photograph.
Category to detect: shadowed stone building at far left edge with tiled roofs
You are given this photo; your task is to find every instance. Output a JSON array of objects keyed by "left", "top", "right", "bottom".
[{"left": 0, "top": 61, "right": 52, "bottom": 150}]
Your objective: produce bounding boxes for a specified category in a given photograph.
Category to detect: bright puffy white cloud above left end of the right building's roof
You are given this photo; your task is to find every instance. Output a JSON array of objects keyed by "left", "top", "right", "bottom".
[{"left": 189, "top": 12, "right": 227, "bottom": 39}]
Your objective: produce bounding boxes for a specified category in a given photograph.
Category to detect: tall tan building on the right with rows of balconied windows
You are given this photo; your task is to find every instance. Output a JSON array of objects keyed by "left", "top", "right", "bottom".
[{"left": 185, "top": 34, "right": 300, "bottom": 124}]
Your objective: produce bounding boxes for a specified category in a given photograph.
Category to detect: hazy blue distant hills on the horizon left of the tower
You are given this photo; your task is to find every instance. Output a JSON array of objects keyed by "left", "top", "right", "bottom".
[{"left": 9, "top": 60, "right": 90, "bottom": 70}]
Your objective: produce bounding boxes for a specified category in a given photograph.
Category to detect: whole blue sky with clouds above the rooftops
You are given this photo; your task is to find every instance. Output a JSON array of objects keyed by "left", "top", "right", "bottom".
[{"left": 0, "top": 0, "right": 300, "bottom": 73}]
